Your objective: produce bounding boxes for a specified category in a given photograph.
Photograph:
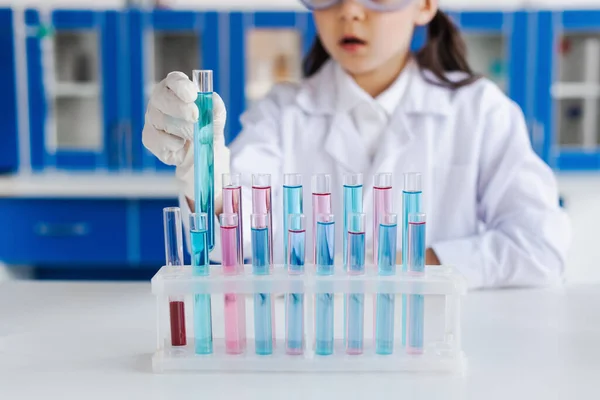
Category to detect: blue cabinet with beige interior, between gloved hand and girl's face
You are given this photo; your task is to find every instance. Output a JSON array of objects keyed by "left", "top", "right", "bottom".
[{"left": 227, "top": 11, "right": 315, "bottom": 143}]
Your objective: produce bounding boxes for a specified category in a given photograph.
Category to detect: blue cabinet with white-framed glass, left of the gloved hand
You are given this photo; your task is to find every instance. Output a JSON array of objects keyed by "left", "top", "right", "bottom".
[{"left": 25, "top": 10, "right": 127, "bottom": 170}]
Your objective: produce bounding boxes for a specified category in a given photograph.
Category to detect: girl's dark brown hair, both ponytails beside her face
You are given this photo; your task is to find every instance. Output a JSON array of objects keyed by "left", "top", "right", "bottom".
[{"left": 303, "top": 10, "right": 479, "bottom": 89}]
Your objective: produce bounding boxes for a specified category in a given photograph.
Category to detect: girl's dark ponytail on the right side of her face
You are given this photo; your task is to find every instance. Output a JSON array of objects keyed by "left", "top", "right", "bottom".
[{"left": 416, "top": 10, "right": 479, "bottom": 89}]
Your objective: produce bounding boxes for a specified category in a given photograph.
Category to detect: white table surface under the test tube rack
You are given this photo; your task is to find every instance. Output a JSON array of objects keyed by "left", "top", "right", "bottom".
[{"left": 0, "top": 281, "right": 600, "bottom": 400}]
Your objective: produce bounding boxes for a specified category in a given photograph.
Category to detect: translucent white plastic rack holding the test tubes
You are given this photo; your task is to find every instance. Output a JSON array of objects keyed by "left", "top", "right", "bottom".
[{"left": 152, "top": 264, "right": 467, "bottom": 375}]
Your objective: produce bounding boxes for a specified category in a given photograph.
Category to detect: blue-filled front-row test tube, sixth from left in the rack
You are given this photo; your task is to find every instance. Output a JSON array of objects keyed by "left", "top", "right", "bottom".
[{"left": 315, "top": 214, "right": 335, "bottom": 356}]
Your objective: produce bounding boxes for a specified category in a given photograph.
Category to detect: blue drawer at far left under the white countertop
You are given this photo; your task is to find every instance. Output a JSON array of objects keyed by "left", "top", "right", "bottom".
[{"left": 0, "top": 199, "right": 127, "bottom": 267}]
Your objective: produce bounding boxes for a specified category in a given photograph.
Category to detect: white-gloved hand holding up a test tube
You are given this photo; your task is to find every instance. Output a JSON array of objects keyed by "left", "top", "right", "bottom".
[{"left": 142, "top": 72, "right": 230, "bottom": 205}]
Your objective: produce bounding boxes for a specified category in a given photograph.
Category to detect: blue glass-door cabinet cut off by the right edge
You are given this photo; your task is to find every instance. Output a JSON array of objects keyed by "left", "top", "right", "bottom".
[{"left": 535, "top": 10, "right": 600, "bottom": 171}]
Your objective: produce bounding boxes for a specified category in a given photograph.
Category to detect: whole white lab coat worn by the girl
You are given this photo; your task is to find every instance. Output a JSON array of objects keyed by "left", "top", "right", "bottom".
[{"left": 181, "top": 61, "right": 570, "bottom": 288}]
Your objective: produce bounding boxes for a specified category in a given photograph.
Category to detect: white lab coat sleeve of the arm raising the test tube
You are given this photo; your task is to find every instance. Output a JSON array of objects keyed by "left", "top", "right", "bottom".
[{"left": 179, "top": 87, "right": 289, "bottom": 262}]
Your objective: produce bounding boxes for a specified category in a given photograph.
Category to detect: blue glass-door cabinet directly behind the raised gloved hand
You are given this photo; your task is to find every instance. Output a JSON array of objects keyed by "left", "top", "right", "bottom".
[{"left": 126, "top": 9, "right": 220, "bottom": 170}]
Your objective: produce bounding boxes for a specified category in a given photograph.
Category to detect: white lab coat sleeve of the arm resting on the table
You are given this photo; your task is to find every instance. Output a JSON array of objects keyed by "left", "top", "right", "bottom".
[{"left": 432, "top": 101, "right": 571, "bottom": 288}]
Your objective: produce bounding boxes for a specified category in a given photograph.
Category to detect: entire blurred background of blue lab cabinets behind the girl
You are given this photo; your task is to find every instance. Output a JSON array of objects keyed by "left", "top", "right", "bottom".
[{"left": 0, "top": 0, "right": 600, "bottom": 282}]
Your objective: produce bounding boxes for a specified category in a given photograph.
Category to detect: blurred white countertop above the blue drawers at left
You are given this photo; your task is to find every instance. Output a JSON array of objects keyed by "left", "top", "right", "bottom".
[{"left": 0, "top": 171, "right": 177, "bottom": 199}]
